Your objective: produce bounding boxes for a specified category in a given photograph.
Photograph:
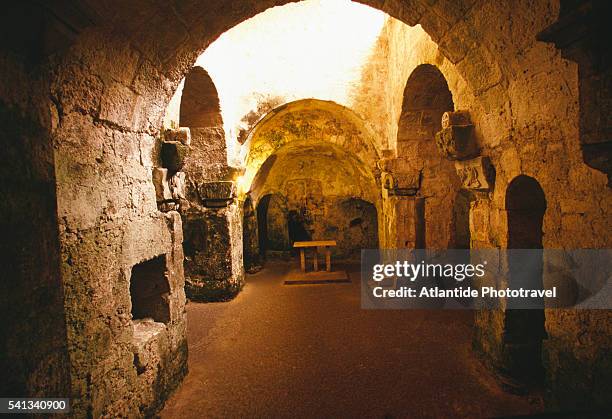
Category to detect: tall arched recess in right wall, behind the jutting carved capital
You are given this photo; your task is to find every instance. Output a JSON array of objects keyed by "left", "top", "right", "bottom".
[{"left": 391, "top": 64, "right": 465, "bottom": 249}]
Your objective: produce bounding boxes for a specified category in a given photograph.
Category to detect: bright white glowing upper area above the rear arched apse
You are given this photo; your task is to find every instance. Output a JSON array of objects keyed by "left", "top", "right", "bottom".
[{"left": 196, "top": 0, "right": 386, "bottom": 136}]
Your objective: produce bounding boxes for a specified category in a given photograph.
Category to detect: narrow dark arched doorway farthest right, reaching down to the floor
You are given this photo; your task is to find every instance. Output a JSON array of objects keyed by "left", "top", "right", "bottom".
[{"left": 503, "top": 175, "right": 546, "bottom": 386}]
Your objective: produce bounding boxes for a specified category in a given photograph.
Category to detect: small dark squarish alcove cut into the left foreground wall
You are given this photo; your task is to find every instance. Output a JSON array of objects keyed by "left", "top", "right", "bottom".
[{"left": 130, "top": 255, "right": 170, "bottom": 323}]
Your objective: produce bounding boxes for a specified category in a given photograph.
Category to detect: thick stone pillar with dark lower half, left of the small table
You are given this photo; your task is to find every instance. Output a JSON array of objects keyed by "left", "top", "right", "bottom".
[{"left": 179, "top": 127, "right": 244, "bottom": 301}]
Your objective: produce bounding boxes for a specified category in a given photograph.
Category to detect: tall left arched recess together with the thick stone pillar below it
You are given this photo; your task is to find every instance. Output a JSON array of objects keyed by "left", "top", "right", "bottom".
[{"left": 164, "top": 66, "right": 245, "bottom": 301}]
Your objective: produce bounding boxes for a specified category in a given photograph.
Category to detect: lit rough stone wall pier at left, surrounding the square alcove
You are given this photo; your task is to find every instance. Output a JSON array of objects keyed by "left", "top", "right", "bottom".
[{"left": 51, "top": 31, "right": 187, "bottom": 416}]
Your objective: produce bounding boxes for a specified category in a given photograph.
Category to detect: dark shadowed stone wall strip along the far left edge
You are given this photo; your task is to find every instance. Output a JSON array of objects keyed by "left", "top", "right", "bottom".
[{"left": 0, "top": 49, "right": 70, "bottom": 397}]
